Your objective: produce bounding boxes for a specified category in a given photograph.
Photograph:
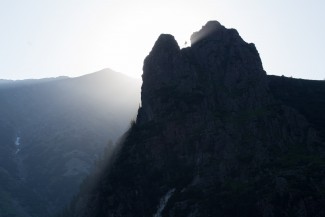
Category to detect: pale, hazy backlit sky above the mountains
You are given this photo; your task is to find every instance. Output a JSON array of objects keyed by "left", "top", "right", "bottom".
[{"left": 0, "top": 0, "right": 325, "bottom": 79}]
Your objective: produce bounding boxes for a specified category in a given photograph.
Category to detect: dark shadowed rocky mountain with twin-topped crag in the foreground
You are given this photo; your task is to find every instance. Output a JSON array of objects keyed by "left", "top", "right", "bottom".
[{"left": 66, "top": 21, "right": 325, "bottom": 217}]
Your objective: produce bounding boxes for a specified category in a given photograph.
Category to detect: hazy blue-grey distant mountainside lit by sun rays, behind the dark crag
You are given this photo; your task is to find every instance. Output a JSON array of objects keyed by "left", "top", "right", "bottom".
[{"left": 0, "top": 69, "right": 141, "bottom": 217}]
